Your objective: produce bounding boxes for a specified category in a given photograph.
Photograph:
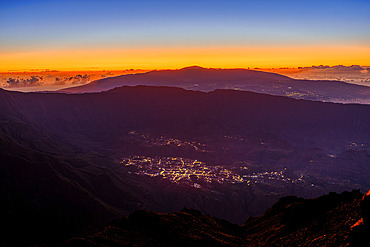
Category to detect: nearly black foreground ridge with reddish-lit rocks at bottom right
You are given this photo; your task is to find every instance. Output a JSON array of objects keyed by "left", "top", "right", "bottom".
[{"left": 61, "top": 190, "right": 370, "bottom": 246}]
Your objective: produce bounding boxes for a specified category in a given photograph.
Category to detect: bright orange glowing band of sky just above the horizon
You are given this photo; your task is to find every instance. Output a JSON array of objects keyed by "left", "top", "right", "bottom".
[{"left": 0, "top": 46, "right": 370, "bottom": 72}]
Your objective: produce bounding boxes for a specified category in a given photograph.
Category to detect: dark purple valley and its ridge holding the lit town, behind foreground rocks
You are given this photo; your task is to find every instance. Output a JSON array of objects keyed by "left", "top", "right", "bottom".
[{"left": 0, "top": 86, "right": 370, "bottom": 245}]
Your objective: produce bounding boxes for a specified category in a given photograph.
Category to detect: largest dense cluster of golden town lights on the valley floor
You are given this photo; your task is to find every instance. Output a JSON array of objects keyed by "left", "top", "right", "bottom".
[{"left": 120, "top": 156, "right": 304, "bottom": 188}]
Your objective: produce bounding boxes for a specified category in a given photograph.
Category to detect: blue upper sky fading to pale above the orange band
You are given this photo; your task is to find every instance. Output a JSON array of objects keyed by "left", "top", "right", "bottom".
[{"left": 0, "top": 0, "right": 370, "bottom": 50}]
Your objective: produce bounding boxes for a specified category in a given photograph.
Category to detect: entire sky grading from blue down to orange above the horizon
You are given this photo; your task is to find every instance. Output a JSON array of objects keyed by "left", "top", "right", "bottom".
[{"left": 0, "top": 0, "right": 370, "bottom": 71}]
